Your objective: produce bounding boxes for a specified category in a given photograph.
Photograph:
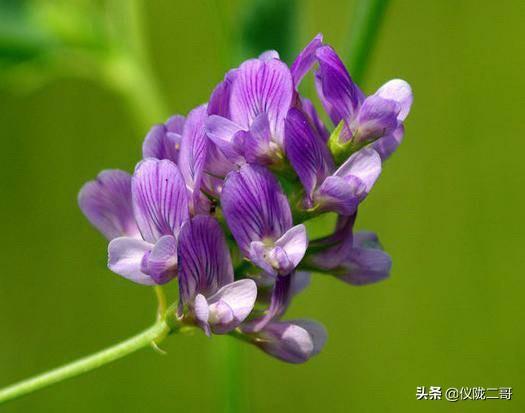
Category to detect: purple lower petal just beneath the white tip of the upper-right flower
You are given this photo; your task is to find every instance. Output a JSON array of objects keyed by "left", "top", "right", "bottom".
[{"left": 353, "top": 95, "right": 399, "bottom": 142}]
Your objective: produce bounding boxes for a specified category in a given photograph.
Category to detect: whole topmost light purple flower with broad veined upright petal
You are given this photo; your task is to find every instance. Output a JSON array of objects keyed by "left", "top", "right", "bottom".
[{"left": 206, "top": 52, "right": 294, "bottom": 165}]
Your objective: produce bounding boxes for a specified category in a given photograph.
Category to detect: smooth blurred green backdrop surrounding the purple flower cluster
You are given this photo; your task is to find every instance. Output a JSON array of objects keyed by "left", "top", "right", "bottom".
[{"left": 0, "top": 0, "right": 525, "bottom": 413}]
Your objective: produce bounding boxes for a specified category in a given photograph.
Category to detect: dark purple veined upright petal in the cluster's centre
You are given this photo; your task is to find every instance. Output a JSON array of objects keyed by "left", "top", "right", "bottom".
[{"left": 221, "top": 165, "right": 292, "bottom": 256}]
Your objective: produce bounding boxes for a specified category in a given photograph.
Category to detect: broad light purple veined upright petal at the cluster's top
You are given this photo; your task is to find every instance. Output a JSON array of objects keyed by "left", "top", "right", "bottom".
[{"left": 230, "top": 59, "right": 293, "bottom": 145}]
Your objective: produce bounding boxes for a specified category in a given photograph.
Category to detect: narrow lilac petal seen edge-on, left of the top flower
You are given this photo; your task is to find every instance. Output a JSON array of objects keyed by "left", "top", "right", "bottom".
[{"left": 179, "top": 105, "right": 210, "bottom": 213}]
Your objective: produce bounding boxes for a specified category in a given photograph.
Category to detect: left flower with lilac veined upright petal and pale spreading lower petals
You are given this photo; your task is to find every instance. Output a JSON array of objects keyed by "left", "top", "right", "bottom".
[{"left": 108, "top": 159, "right": 189, "bottom": 285}]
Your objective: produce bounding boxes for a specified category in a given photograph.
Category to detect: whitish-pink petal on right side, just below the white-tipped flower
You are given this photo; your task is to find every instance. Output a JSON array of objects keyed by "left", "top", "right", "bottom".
[{"left": 334, "top": 148, "right": 381, "bottom": 195}]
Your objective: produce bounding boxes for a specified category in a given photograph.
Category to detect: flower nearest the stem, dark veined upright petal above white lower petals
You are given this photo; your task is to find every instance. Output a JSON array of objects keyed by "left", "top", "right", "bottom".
[{"left": 179, "top": 216, "right": 257, "bottom": 335}]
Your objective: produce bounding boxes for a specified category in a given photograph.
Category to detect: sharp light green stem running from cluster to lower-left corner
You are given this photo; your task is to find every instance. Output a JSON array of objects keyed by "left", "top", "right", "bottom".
[{"left": 0, "top": 321, "right": 169, "bottom": 404}]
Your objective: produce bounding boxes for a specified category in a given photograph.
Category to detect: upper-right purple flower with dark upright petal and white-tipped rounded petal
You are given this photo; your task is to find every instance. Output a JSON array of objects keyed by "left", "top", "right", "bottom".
[{"left": 316, "top": 46, "right": 412, "bottom": 159}]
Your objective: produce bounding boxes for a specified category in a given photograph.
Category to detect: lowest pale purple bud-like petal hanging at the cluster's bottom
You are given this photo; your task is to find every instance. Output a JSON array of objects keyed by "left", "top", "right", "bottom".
[{"left": 255, "top": 321, "right": 315, "bottom": 363}]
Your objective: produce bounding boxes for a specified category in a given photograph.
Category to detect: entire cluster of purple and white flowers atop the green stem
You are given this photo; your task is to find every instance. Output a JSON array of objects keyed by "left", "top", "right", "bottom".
[{"left": 79, "top": 35, "right": 412, "bottom": 363}]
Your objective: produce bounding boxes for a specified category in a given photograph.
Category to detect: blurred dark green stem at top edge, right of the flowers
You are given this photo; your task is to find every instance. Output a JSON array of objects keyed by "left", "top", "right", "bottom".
[{"left": 346, "top": 0, "right": 388, "bottom": 83}]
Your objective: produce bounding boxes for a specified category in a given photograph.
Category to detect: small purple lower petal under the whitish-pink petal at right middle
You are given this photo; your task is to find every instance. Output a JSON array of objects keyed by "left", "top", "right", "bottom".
[{"left": 315, "top": 176, "right": 360, "bottom": 216}]
